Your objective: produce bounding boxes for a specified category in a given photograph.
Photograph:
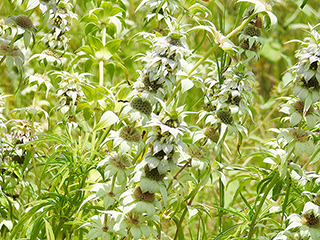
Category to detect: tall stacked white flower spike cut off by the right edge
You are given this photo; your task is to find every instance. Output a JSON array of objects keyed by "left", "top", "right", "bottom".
[{"left": 278, "top": 27, "right": 320, "bottom": 159}]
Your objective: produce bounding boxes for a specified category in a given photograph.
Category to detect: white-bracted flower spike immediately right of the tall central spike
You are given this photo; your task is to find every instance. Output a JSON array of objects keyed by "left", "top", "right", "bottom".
[{"left": 193, "top": 64, "right": 254, "bottom": 144}]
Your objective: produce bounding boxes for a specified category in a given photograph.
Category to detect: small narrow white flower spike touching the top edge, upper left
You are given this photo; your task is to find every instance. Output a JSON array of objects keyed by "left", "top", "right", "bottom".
[{"left": 42, "top": 0, "right": 77, "bottom": 49}]
